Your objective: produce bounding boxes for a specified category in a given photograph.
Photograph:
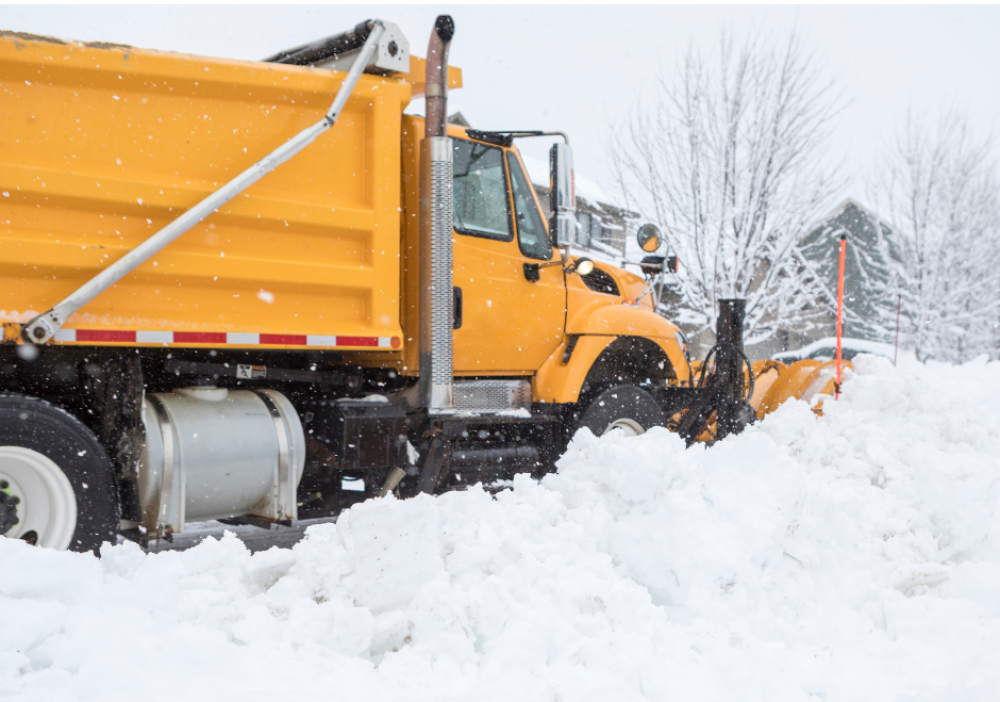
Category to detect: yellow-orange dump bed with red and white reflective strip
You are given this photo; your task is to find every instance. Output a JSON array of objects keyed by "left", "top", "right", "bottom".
[{"left": 0, "top": 33, "right": 414, "bottom": 349}]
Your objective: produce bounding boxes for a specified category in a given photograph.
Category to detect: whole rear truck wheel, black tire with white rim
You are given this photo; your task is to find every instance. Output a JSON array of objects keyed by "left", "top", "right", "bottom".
[{"left": 0, "top": 395, "right": 119, "bottom": 552}]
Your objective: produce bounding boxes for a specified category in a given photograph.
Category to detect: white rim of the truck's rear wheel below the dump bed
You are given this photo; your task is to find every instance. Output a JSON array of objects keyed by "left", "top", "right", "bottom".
[{"left": 0, "top": 446, "right": 76, "bottom": 550}]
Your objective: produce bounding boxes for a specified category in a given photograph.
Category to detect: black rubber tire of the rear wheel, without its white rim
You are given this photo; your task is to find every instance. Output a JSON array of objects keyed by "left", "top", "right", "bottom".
[{"left": 0, "top": 394, "right": 120, "bottom": 553}]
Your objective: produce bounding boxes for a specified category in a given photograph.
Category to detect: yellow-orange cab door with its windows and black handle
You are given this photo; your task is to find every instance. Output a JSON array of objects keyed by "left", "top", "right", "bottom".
[{"left": 453, "top": 139, "right": 566, "bottom": 375}]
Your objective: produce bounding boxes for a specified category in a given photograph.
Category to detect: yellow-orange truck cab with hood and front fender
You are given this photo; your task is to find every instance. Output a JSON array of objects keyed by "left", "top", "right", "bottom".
[{"left": 378, "top": 116, "right": 688, "bottom": 403}]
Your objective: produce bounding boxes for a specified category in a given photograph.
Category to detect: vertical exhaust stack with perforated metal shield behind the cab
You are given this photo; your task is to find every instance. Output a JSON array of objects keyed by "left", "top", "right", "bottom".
[{"left": 419, "top": 15, "right": 455, "bottom": 414}]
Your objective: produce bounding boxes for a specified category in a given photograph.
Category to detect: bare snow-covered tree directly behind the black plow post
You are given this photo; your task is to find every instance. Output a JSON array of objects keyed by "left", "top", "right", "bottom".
[{"left": 610, "top": 35, "right": 842, "bottom": 343}]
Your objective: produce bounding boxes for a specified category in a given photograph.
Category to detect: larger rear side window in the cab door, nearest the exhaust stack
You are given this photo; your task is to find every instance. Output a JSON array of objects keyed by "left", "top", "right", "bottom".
[{"left": 452, "top": 139, "right": 514, "bottom": 241}]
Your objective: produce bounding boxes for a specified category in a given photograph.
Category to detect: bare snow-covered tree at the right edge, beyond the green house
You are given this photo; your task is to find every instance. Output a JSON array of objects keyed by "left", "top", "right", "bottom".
[{"left": 874, "top": 113, "right": 1000, "bottom": 362}]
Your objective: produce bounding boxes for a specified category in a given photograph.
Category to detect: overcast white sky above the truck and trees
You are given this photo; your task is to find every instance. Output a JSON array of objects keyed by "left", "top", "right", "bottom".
[{"left": 0, "top": 4, "right": 1000, "bottom": 209}]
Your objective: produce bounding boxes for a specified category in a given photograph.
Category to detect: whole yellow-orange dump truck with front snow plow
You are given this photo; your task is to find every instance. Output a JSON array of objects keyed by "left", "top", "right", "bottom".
[{"left": 0, "top": 16, "right": 844, "bottom": 551}]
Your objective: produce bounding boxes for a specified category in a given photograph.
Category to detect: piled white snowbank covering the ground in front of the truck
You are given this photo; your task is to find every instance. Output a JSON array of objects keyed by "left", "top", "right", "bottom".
[{"left": 0, "top": 357, "right": 1000, "bottom": 702}]
